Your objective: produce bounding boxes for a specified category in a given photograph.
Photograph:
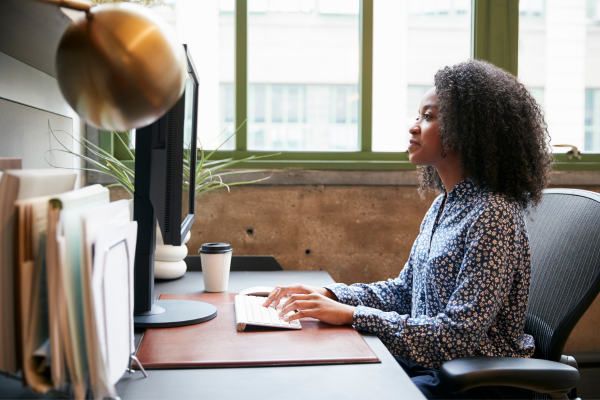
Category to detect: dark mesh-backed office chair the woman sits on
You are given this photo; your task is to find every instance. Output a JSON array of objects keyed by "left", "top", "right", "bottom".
[{"left": 440, "top": 189, "right": 600, "bottom": 399}]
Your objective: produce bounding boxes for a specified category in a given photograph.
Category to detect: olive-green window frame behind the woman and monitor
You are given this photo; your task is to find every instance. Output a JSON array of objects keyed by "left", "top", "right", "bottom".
[{"left": 100, "top": 0, "right": 600, "bottom": 171}]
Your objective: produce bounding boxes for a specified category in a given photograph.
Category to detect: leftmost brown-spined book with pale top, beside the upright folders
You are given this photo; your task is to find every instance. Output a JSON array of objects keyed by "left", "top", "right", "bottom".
[{"left": 0, "top": 169, "right": 76, "bottom": 373}]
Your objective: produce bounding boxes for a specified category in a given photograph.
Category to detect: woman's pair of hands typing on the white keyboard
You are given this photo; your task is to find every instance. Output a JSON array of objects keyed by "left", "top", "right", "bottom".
[{"left": 263, "top": 283, "right": 354, "bottom": 325}]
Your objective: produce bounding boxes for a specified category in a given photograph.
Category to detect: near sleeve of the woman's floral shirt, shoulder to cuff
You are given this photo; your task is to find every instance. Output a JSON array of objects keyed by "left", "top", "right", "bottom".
[{"left": 354, "top": 210, "right": 518, "bottom": 368}]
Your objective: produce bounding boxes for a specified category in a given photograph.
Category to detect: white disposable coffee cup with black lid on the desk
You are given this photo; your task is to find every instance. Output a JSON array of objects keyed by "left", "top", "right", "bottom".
[{"left": 200, "top": 243, "right": 233, "bottom": 292}]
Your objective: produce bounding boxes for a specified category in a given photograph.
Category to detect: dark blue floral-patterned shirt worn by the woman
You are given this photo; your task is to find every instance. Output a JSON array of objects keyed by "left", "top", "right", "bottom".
[{"left": 327, "top": 179, "right": 535, "bottom": 368}]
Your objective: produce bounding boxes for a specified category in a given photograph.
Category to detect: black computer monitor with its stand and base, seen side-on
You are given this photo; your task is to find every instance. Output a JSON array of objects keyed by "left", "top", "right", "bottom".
[{"left": 133, "top": 45, "right": 217, "bottom": 328}]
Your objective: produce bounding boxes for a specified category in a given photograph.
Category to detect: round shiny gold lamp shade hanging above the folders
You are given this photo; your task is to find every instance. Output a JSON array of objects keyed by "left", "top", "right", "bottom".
[{"left": 56, "top": 3, "right": 187, "bottom": 131}]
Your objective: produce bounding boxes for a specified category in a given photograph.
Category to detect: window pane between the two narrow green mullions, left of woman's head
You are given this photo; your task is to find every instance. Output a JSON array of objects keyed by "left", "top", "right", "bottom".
[{"left": 248, "top": 0, "right": 359, "bottom": 151}]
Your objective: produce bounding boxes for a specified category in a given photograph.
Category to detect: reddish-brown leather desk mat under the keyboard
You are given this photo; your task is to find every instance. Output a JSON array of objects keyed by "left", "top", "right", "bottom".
[{"left": 137, "top": 293, "right": 380, "bottom": 369}]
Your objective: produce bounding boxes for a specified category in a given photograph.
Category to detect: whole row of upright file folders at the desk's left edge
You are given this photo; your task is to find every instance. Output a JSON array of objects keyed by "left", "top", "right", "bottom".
[{"left": 0, "top": 169, "right": 137, "bottom": 399}]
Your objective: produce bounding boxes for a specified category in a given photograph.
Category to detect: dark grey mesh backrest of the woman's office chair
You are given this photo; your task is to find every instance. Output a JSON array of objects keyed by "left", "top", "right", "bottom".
[{"left": 525, "top": 189, "right": 600, "bottom": 361}]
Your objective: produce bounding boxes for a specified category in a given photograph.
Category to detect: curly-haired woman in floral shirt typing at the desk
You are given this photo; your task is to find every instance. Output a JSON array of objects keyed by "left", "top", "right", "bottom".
[{"left": 265, "top": 61, "right": 552, "bottom": 398}]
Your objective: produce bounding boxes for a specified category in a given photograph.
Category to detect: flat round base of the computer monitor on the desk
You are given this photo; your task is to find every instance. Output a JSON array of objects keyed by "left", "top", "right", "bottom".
[{"left": 133, "top": 300, "right": 217, "bottom": 328}]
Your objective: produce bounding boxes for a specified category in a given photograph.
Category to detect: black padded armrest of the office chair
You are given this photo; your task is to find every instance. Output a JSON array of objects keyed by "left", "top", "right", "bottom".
[{"left": 440, "top": 357, "right": 579, "bottom": 393}]
